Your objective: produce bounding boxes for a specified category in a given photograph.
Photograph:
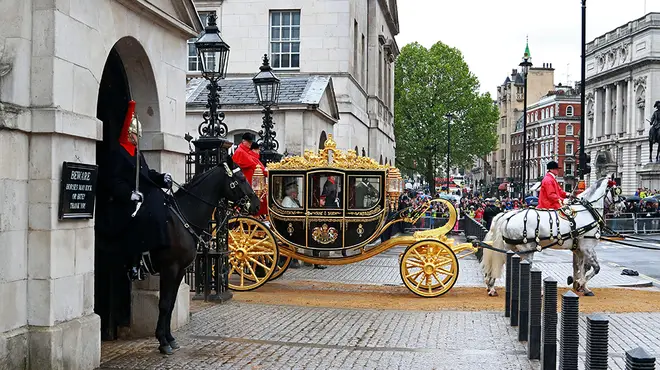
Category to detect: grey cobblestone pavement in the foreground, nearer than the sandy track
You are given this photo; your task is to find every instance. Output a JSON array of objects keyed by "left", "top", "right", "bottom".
[{"left": 101, "top": 302, "right": 660, "bottom": 370}]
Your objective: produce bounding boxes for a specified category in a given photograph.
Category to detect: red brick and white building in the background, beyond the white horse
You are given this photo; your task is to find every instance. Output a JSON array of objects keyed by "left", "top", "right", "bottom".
[{"left": 511, "top": 85, "right": 582, "bottom": 190}]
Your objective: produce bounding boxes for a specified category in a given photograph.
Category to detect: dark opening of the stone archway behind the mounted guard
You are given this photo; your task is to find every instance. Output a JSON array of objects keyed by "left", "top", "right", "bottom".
[{"left": 94, "top": 48, "right": 131, "bottom": 340}]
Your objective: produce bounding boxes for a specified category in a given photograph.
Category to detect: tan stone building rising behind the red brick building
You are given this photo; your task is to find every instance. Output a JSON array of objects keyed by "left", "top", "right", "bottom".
[{"left": 490, "top": 59, "right": 555, "bottom": 183}]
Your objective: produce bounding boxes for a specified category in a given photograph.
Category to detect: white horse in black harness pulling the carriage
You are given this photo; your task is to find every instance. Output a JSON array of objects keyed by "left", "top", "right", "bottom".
[{"left": 481, "top": 176, "right": 618, "bottom": 296}]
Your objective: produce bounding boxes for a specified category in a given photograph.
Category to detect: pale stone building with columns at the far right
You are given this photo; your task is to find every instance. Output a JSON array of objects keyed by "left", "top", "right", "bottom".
[{"left": 585, "top": 13, "right": 660, "bottom": 195}]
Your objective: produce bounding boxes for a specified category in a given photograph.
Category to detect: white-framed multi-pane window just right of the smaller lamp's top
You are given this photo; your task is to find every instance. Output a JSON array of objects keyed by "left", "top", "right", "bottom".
[{"left": 270, "top": 10, "right": 300, "bottom": 69}]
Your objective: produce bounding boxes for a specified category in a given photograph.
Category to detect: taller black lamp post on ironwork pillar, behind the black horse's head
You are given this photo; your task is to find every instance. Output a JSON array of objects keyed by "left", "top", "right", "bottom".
[{"left": 188, "top": 13, "right": 232, "bottom": 301}]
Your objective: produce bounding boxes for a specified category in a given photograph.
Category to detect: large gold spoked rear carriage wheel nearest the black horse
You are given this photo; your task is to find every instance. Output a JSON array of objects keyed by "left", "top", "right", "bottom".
[{"left": 227, "top": 217, "right": 279, "bottom": 291}]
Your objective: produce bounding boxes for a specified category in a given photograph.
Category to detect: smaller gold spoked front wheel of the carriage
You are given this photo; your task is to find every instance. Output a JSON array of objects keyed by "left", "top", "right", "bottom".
[{"left": 400, "top": 240, "right": 458, "bottom": 297}]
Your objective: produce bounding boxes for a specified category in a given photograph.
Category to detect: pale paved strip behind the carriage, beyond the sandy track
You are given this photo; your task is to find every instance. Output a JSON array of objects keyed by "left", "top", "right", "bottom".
[{"left": 280, "top": 243, "right": 652, "bottom": 288}]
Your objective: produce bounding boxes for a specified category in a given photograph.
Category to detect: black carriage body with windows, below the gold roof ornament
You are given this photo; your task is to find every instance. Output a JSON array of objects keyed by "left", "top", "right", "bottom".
[{"left": 268, "top": 168, "right": 387, "bottom": 250}]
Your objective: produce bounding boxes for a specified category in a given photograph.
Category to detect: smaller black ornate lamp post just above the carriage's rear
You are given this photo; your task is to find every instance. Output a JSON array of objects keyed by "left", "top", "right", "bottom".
[{"left": 252, "top": 54, "right": 282, "bottom": 163}]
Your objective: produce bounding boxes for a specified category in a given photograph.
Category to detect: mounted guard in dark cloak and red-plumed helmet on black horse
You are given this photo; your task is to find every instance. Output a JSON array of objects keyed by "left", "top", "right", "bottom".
[{"left": 95, "top": 100, "right": 172, "bottom": 280}]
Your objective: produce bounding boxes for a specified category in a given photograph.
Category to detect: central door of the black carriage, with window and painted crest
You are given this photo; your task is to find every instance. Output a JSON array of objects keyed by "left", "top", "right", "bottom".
[{"left": 307, "top": 170, "right": 346, "bottom": 250}]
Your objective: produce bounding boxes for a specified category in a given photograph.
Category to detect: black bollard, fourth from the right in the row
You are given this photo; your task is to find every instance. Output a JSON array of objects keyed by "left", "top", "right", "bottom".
[{"left": 541, "top": 277, "right": 557, "bottom": 370}]
